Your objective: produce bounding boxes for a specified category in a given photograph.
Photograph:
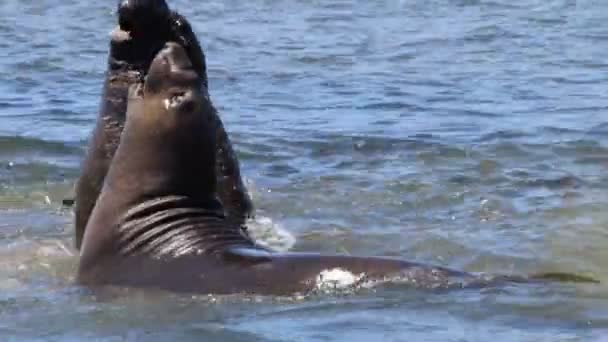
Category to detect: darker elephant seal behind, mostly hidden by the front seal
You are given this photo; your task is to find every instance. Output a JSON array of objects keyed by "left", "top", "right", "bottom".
[{"left": 74, "top": 0, "right": 253, "bottom": 249}]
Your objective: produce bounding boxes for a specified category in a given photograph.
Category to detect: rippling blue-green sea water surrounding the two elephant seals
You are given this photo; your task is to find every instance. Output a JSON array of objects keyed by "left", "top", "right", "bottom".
[{"left": 0, "top": 0, "right": 608, "bottom": 342}]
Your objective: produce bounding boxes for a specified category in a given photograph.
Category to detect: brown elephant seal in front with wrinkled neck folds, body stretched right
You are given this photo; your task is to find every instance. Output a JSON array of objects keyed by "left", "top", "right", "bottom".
[{"left": 77, "top": 43, "right": 600, "bottom": 295}]
